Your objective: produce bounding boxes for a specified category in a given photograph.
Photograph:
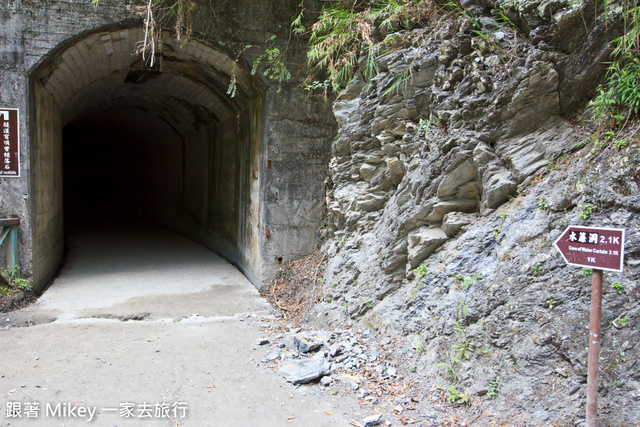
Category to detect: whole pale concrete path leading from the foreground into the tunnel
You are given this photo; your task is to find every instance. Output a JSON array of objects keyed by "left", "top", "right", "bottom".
[{"left": 0, "top": 229, "right": 355, "bottom": 426}]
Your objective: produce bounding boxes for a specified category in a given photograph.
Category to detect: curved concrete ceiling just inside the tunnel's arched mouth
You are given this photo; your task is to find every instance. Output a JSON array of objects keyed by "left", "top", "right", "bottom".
[{"left": 32, "top": 28, "right": 256, "bottom": 130}]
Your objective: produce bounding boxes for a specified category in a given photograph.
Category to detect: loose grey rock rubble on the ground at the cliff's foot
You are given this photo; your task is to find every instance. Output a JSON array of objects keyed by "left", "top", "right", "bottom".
[{"left": 251, "top": 324, "right": 460, "bottom": 426}]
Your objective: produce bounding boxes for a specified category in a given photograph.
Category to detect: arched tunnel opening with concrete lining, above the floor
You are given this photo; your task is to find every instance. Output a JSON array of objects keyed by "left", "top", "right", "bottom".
[{"left": 31, "top": 28, "right": 261, "bottom": 290}]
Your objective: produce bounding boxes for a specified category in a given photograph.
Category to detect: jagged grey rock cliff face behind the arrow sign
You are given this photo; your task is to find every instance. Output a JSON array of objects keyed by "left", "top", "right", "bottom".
[{"left": 308, "top": 0, "right": 640, "bottom": 425}]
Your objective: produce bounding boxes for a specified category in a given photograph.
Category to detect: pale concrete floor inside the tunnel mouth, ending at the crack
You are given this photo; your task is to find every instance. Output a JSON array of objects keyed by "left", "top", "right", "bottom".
[{"left": 34, "top": 227, "right": 270, "bottom": 320}]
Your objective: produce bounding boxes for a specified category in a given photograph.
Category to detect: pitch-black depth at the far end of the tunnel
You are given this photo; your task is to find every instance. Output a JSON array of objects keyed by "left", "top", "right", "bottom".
[{"left": 63, "top": 109, "right": 185, "bottom": 232}]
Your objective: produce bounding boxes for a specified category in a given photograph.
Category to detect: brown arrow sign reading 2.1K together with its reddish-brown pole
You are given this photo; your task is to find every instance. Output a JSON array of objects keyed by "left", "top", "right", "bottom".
[{"left": 555, "top": 226, "right": 624, "bottom": 427}]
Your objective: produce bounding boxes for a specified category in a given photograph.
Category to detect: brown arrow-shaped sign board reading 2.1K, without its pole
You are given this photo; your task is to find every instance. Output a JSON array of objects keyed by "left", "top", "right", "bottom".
[{"left": 555, "top": 226, "right": 624, "bottom": 271}]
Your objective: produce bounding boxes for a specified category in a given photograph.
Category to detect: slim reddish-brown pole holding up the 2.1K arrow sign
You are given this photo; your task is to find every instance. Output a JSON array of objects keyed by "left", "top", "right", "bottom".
[{"left": 586, "top": 270, "right": 602, "bottom": 427}]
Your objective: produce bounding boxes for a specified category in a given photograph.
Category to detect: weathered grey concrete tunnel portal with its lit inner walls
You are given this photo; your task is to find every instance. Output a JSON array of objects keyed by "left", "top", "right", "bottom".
[{"left": 0, "top": 0, "right": 336, "bottom": 294}]
